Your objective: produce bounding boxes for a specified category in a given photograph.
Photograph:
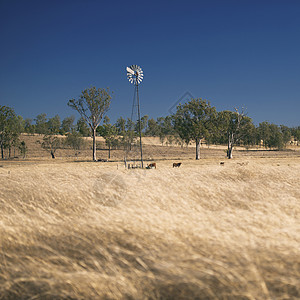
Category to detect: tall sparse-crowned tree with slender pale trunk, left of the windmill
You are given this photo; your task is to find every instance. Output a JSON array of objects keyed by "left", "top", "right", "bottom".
[{"left": 68, "top": 87, "right": 111, "bottom": 161}]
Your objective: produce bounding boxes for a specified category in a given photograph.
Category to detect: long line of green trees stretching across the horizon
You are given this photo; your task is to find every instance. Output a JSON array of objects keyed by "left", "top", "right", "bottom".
[{"left": 0, "top": 87, "right": 300, "bottom": 160}]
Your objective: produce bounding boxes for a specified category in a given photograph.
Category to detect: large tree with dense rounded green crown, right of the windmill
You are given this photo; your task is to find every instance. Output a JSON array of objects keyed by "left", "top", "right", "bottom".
[{"left": 173, "top": 98, "right": 217, "bottom": 160}]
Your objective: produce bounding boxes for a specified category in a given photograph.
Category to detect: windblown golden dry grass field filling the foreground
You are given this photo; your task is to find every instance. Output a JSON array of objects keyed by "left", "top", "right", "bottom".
[{"left": 0, "top": 137, "right": 300, "bottom": 299}]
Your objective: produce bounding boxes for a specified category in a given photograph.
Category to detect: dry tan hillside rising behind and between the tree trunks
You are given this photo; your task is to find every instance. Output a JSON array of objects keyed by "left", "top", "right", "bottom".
[{"left": 2, "top": 134, "right": 300, "bottom": 161}]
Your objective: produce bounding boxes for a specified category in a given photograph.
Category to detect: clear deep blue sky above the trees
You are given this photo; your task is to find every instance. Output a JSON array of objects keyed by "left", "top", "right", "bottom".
[{"left": 0, "top": 0, "right": 300, "bottom": 126}]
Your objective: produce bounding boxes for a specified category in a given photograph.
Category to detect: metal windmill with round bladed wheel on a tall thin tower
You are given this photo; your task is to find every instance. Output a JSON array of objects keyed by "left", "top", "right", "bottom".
[{"left": 126, "top": 65, "right": 144, "bottom": 168}]
